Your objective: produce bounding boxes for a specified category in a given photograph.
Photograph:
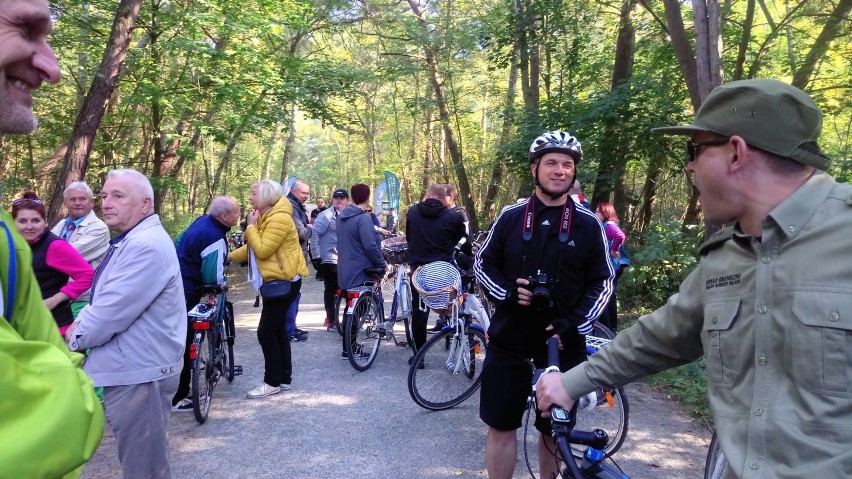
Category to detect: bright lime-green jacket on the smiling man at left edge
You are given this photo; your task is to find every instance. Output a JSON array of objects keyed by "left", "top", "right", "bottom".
[{"left": 0, "top": 211, "right": 104, "bottom": 479}]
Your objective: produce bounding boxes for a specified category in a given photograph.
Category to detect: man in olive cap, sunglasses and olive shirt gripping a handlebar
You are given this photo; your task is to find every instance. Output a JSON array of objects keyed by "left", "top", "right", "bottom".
[{"left": 537, "top": 80, "right": 852, "bottom": 478}]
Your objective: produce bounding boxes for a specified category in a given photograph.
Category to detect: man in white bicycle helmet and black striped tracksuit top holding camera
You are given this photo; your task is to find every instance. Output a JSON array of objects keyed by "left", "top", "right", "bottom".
[{"left": 474, "top": 131, "right": 613, "bottom": 479}]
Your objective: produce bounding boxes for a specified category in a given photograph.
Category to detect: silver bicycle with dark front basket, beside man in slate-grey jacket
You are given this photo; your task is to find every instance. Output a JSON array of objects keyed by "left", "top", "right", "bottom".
[{"left": 341, "top": 236, "right": 414, "bottom": 371}]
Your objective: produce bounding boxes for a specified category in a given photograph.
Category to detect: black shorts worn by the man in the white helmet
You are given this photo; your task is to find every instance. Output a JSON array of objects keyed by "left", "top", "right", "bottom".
[{"left": 479, "top": 348, "right": 586, "bottom": 435}]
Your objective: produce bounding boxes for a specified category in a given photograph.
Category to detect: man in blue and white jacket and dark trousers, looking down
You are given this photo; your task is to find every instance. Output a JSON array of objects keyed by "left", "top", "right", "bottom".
[{"left": 172, "top": 196, "right": 240, "bottom": 412}]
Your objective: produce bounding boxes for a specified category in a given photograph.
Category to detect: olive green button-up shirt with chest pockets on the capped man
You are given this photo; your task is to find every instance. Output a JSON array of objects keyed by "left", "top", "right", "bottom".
[{"left": 563, "top": 173, "right": 852, "bottom": 479}]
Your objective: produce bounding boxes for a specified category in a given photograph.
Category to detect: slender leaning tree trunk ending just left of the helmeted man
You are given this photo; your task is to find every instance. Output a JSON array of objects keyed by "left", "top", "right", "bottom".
[{"left": 408, "top": 0, "right": 479, "bottom": 233}]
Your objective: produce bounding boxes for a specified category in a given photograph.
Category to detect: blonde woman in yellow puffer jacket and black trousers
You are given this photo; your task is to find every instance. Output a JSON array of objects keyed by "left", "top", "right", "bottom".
[{"left": 228, "top": 180, "right": 308, "bottom": 399}]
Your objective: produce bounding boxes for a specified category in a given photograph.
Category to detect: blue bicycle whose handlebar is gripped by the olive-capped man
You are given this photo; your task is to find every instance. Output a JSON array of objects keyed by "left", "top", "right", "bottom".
[{"left": 532, "top": 336, "right": 629, "bottom": 479}]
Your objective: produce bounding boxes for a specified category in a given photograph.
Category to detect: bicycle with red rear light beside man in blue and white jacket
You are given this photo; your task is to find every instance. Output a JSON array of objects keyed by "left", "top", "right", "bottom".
[{"left": 187, "top": 285, "right": 243, "bottom": 424}]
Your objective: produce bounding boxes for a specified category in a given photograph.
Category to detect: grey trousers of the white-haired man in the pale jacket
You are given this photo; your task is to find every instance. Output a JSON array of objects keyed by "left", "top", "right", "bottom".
[{"left": 104, "top": 376, "right": 179, "bottom": 479}]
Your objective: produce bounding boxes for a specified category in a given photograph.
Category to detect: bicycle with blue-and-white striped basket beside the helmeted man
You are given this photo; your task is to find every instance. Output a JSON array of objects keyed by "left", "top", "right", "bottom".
[{"left": 408, "top": 258, "right": 490, "bottom": 411}]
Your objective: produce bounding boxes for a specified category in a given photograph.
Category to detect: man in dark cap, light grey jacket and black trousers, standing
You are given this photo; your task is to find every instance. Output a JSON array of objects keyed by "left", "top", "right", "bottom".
[{"left": 311, "top": 189, "right": 349, "bottom": 331}]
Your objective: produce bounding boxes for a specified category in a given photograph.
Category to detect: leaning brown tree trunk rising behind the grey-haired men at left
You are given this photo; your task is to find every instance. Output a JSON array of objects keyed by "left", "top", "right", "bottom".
[{"left": 48, "top": 0, "right": 142, "bottom": 224}]
